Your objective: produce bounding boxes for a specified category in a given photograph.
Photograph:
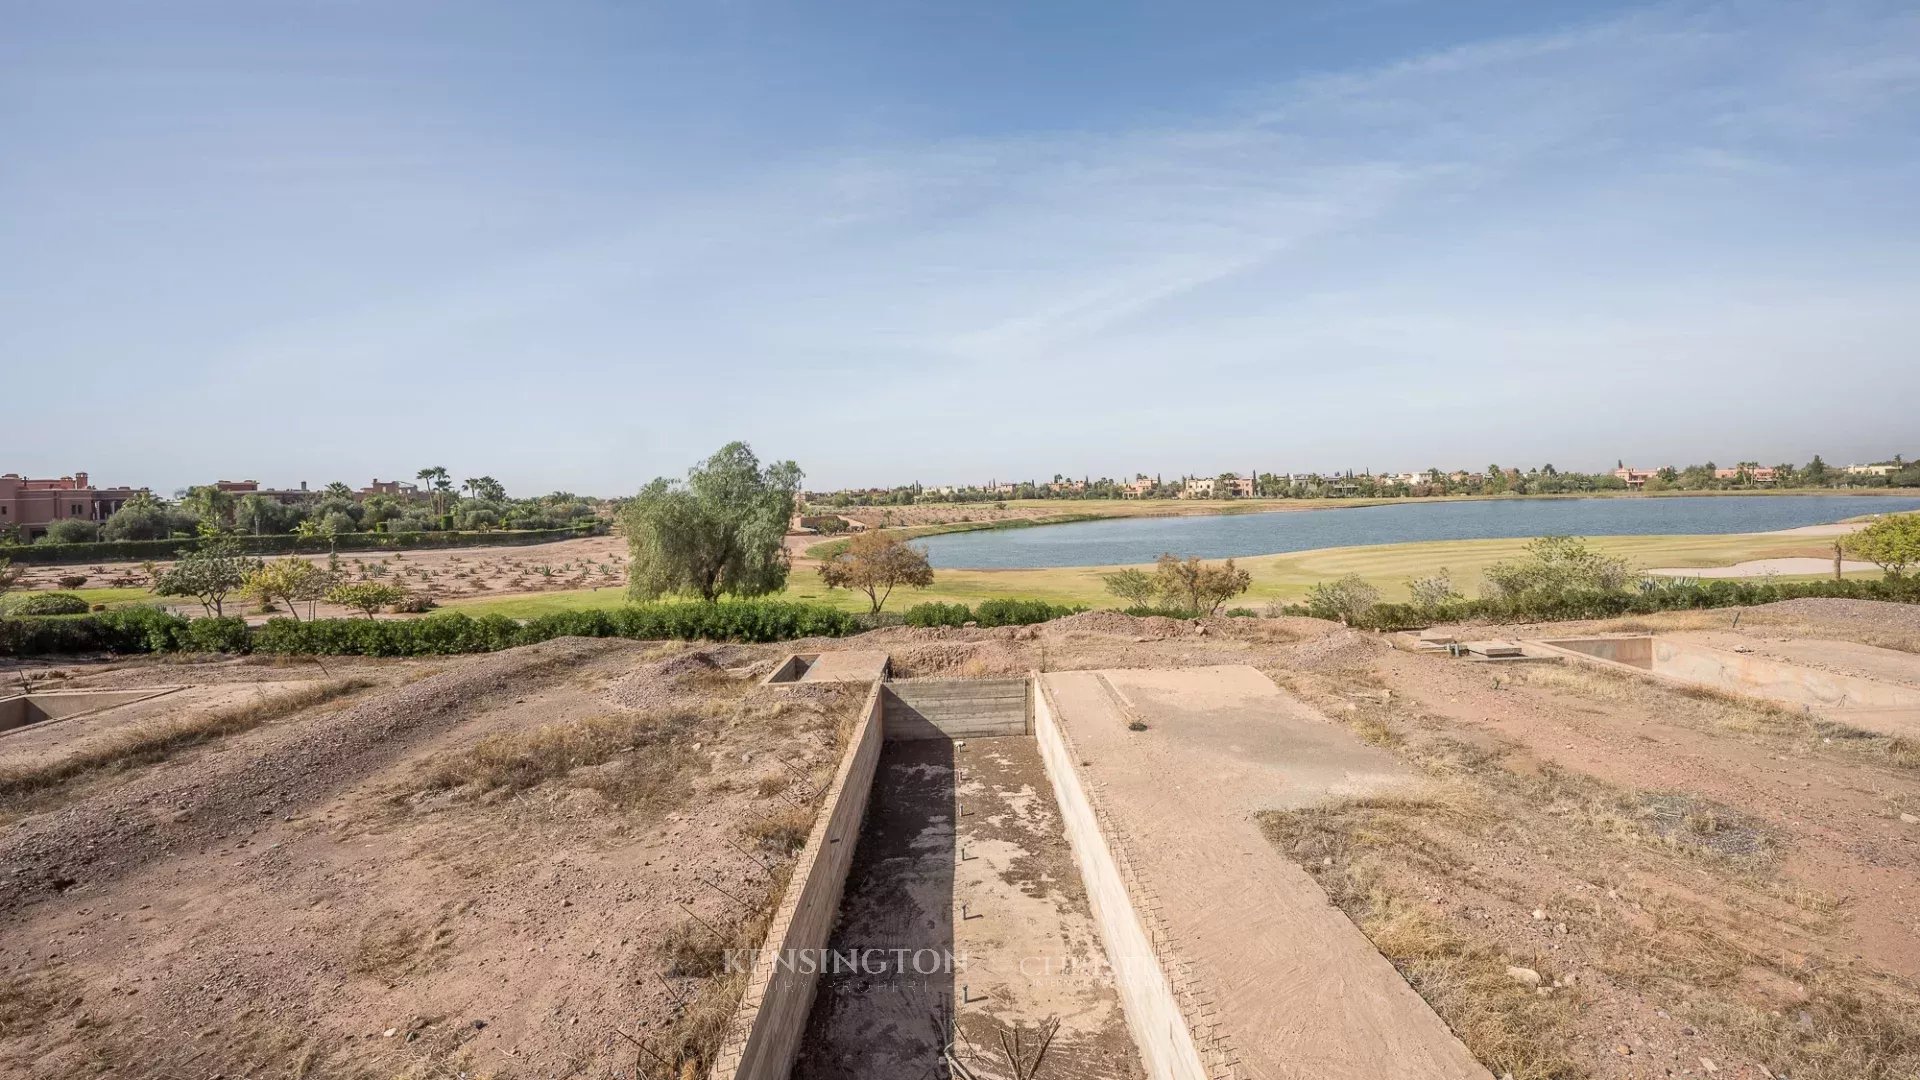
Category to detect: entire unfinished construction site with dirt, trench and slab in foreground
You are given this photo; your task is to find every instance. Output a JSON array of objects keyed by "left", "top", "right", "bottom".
[{"left": 0, "top": 600, "right": 1920, "bottom": 1080}]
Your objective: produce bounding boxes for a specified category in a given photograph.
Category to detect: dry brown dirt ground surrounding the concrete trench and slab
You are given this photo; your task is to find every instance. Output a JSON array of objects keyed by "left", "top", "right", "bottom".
[{"left": 0, "top": 601, "right": 1920, "bottom": 1080}]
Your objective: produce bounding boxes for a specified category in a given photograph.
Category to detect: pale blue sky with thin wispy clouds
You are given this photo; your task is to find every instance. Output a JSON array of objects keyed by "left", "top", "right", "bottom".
[{"left": 0, "top": 0, "right": 1920, "bottom": 496}]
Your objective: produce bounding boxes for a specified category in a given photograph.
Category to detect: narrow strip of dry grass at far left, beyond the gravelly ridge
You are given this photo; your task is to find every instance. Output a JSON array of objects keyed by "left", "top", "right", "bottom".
[{"left": 0, "top": 678, "right": 374, "bottom": 813}]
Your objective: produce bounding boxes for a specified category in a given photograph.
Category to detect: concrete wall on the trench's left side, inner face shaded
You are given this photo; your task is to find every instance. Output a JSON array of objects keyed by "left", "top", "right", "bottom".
[{"left": 708, "top": 682, "right": 885, "bottom": 1080}]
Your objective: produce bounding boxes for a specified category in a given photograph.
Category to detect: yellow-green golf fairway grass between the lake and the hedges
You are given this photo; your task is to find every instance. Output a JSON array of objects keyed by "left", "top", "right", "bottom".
[{"left": 449, "top": 532, "right": 1876, "bottom": 619}]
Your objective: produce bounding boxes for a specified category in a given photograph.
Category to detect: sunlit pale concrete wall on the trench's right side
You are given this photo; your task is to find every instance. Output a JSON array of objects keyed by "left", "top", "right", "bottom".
[{"left": 1033, "top": 675, "right": 1210, "bottom": 1080}]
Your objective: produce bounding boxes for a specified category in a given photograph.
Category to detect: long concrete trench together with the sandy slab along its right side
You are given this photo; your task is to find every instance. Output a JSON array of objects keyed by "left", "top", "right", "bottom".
[{"left": 710, "top": 661, "right": 1490, "bottom": 1080}]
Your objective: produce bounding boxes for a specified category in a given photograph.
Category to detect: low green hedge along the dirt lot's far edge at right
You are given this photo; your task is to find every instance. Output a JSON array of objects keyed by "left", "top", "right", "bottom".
[{"left": 1344, "top": 578, "right": 1920, "bottom": 630}]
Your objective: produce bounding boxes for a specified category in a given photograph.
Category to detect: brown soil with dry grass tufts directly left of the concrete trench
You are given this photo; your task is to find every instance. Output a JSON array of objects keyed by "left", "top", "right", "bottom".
[{"left": 0, "top": 640, "right": 858, "bottom": 1078}]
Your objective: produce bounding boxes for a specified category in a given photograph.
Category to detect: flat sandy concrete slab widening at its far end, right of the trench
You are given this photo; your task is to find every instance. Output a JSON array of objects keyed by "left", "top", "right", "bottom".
[{"left": 1043, "top": 667, "right": 1490, "bottom": 1080}]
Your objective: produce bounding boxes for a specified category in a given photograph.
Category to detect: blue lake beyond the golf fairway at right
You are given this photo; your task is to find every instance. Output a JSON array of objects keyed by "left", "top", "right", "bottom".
[{"left": 918, "top": 496, "right": 1920, "bottom": 569}]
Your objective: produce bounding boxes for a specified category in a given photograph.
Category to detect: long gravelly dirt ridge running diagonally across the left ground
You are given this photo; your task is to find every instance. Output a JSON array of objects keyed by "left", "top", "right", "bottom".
[{"left": 0, "top": 638, "right": 632, "bottom": 911}]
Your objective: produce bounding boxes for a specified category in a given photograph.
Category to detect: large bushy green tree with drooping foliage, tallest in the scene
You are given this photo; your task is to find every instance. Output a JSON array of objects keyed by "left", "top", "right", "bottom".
[{"left": 620, "top": 442, "right": 801, "bottom": 600}]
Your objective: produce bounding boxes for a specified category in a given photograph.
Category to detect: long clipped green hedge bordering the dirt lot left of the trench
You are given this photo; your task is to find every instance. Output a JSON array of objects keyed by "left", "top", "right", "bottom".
[{"left": 0, "top": 600, "right": 860, "bottom": 655}]
